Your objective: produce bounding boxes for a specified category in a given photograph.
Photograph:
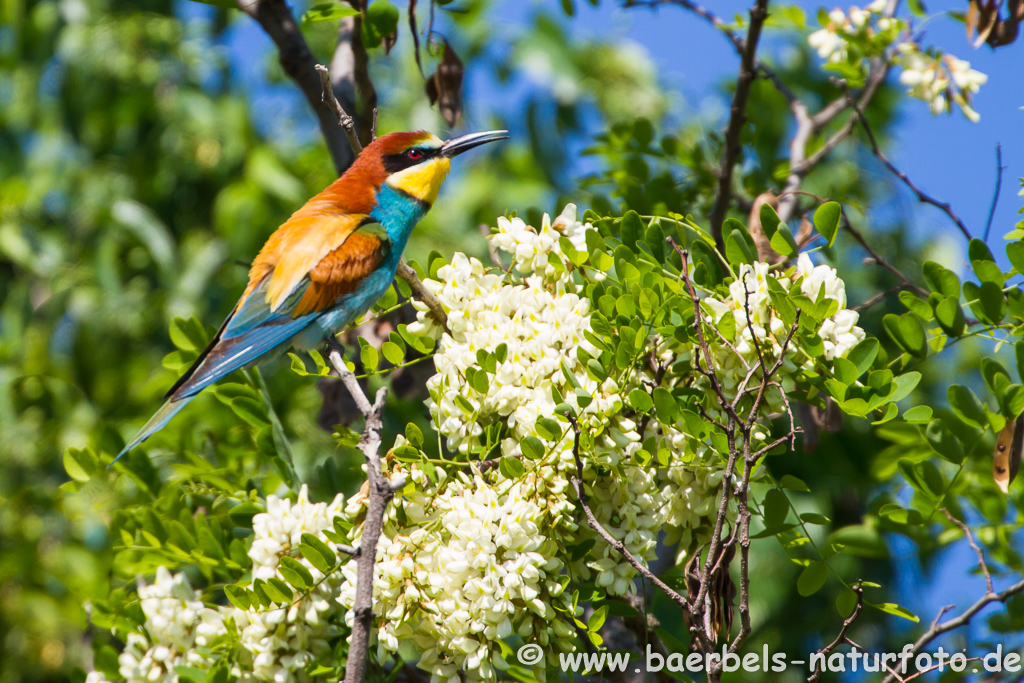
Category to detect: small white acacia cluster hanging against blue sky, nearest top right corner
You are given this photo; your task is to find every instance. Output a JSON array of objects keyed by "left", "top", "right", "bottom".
[{"left": 896, "top": 42, "right": 988, "bottom": 123}]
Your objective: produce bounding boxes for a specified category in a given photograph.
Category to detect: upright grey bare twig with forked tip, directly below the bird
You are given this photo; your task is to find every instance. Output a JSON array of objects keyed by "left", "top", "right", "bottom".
[{"left": 328, "top": 337, "right": 403, "bottom": 683}]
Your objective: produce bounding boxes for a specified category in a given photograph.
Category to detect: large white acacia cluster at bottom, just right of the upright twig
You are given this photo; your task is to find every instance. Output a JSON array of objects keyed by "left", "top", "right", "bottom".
[{"left": 341, "top": 466, "right": 574, "bottom": 683}]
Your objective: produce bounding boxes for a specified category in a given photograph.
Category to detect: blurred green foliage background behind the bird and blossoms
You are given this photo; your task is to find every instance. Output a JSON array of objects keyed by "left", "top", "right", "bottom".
[{"left": 0, "top": 0, "right": 1020, "bottom": 683}]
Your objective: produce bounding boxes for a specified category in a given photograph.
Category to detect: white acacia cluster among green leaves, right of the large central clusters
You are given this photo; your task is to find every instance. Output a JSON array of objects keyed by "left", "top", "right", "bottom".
[{"left": 703, "top": 254, "right": 864, "bottom": 391}]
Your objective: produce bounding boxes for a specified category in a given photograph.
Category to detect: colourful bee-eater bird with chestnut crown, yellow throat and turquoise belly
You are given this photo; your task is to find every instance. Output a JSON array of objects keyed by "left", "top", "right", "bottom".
[{"left": 115, "top": 130, "right": 508, "bottom": 462}]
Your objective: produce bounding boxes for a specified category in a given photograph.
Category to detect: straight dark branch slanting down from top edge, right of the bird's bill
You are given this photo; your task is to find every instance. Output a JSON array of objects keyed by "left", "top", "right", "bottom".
[{"left": 710, "top": 0, "right": 768, "bottom": 245}]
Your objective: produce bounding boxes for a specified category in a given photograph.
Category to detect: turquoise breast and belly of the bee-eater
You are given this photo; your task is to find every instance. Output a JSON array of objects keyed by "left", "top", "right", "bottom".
[{"left": 295, "top": 183, "right": 430, "bottom": 348}]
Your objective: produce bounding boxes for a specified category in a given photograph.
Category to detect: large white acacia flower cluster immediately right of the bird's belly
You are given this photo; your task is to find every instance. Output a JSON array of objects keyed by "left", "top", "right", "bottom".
[{"left": 410, "top": 204, "right": 623, "bottom": 455}]
